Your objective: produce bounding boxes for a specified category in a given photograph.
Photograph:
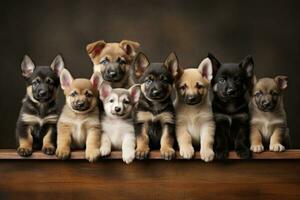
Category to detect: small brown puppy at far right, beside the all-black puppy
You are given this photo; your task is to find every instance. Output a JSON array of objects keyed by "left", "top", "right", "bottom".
[{"left": 250, "top": 76, "right": 290, "bottom": 153}]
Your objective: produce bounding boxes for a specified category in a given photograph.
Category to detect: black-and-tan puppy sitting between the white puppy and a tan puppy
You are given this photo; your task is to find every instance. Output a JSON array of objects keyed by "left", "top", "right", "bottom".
[{"left": 130, "top": 53, "right": 180, "bottom": 160}]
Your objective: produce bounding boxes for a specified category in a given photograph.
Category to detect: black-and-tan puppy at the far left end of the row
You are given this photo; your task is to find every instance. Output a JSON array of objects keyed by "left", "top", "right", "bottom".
[{"left": 16, "top": 55, "right": 64, "bottom": 156}]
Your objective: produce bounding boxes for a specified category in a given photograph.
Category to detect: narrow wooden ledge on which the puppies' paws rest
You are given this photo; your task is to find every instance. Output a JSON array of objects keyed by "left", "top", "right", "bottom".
[{"left": 0, "top": 149, "right": 300, "bottom": 160}]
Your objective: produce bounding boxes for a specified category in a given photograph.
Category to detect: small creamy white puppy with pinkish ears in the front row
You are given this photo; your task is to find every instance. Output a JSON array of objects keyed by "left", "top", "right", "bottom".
[{"left": 100, "top": 83, "right": 140, "bottom": 164}]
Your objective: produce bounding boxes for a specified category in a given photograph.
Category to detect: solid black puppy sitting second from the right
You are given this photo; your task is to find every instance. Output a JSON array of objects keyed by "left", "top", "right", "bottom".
[{"left": 208, "top": 54, "right": 254, "bottom": 159}]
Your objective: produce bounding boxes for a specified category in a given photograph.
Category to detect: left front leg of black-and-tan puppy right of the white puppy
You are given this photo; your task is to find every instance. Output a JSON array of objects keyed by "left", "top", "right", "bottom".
[{"left": 135, "top": 123, "right": 150, "bottom": 160}]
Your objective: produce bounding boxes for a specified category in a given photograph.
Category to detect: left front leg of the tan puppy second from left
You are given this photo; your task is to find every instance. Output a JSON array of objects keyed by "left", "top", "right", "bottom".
[{"left": 56, "top": 122, "right": 72, "bottom": 160}]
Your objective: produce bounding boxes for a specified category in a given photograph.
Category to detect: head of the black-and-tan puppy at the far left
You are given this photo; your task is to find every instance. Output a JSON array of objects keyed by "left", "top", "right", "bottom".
[{"left": 21, "top": 55, "right": 64, "bottom": 103}]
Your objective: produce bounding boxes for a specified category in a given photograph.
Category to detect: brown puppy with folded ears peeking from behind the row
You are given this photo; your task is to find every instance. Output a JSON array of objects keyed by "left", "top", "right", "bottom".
[{"left": 86, "top": 40, "right": 140, "bottom": 88}]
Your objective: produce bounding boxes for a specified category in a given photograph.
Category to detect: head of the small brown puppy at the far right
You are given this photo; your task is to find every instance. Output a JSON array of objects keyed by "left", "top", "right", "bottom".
[{"left": 253, "top": 76, "right": 288, "bottom": 112}]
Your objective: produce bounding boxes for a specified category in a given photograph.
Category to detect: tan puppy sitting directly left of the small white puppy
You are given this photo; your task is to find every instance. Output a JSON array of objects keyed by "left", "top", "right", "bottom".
[{"left": 56, "top": 69, "right": 101, "bottom": 162}]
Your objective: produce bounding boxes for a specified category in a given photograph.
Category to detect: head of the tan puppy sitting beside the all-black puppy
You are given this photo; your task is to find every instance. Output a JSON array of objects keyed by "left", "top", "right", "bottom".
[{"left": 176, "top": 58, "right": 212, "bottom": 105}]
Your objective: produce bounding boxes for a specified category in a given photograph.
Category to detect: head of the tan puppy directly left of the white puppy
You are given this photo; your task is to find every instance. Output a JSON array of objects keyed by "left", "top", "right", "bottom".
[{"left": 60, "top": 69, "right": 100, "bottom": 114}]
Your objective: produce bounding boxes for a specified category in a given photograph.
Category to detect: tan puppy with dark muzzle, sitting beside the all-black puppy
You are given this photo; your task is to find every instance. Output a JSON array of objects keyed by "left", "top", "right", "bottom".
[{"left": 176, "top": 58, "right": 215, "bottom": 162}]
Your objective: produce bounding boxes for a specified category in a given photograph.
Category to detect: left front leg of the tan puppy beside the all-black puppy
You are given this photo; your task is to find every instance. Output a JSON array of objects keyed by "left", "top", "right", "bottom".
[{"left": 176, "top": 125, "right": 195, "bottom": 159}]
